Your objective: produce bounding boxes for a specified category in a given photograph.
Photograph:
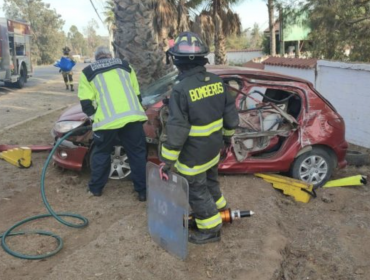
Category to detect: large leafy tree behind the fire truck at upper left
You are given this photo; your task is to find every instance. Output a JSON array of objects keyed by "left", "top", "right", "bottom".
[{"left": 3, "top": 0, "right": 65, "bottom": 64}]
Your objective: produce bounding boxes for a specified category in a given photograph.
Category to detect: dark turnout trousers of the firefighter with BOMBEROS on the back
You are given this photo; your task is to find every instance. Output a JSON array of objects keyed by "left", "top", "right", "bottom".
[{"left": 182, "top": 164, "right": 222, "bottom": 232}]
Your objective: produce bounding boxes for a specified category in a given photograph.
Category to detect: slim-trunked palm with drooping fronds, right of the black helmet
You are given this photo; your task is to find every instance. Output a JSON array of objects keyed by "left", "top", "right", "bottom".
[{"left": 187, "top": 0, "right": 241, "bottom": 64}]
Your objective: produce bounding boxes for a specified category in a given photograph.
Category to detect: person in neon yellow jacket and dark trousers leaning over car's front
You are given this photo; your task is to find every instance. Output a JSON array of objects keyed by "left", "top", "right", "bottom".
[{"left": 78, "top": 47, "right": 148, "bottom": 201}]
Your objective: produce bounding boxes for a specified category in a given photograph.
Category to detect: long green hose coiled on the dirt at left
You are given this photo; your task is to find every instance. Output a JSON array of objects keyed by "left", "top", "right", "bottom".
[{"left": 0, "top": 126, "right": 91, "bottom": 260}]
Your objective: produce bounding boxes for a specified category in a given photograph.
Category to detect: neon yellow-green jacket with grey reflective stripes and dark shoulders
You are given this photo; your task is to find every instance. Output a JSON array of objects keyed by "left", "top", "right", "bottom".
[{"left": 78, "top": 58, "right": 147, "bottom": 131}]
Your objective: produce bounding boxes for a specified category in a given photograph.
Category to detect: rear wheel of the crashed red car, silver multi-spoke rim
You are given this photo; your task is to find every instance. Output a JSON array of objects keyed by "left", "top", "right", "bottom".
[{"left": 291, "top": 147, "right": 334, "bottom": 188}]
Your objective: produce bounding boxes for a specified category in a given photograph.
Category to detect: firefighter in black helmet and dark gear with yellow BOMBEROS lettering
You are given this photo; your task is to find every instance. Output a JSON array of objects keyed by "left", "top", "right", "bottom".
[{"left": 160, "top": 32, "right": 239, "bottom": 244}]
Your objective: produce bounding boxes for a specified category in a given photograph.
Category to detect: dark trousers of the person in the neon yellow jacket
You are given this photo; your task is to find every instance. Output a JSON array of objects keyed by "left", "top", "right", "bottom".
[{"left": 89, "top": 122, "right": 146, "bottom": 196}]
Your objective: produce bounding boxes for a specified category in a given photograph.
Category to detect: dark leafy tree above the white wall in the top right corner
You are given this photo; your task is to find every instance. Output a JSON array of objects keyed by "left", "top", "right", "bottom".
[{"left": 303, "top": 0, "right": 370, "bottom": 62}]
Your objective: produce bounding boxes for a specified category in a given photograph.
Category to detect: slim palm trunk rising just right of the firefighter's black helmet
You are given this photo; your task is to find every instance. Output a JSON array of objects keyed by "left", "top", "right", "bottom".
[{"left": 213, "top": 0, "right": 227, "bottom": 65}]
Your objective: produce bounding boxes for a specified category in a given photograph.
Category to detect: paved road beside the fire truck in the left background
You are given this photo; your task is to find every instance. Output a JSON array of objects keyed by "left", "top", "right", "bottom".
[{"left": 0, "top": 63, "right": 87, "bottom": 131}]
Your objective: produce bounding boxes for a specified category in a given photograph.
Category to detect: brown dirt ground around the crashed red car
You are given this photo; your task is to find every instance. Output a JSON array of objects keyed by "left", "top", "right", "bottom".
[{"left": 0, "top": 77, "right": 370, "bottom": 280}]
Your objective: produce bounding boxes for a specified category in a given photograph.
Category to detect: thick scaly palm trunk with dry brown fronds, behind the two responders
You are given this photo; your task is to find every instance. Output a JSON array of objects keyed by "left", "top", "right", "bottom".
[{"left": 113, "top": 0, "right": 189, "bottom": 85}]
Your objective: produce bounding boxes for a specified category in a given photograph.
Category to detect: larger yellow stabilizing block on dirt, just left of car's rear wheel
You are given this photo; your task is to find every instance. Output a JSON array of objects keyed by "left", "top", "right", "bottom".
[{"left": 254, "top": 173, "right": 316, "bottom": 203}]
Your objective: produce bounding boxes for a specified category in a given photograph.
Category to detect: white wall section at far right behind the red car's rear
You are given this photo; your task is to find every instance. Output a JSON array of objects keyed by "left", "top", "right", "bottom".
[{"left": 316, "top": 60, "right": 370, "bottom": 148}]
